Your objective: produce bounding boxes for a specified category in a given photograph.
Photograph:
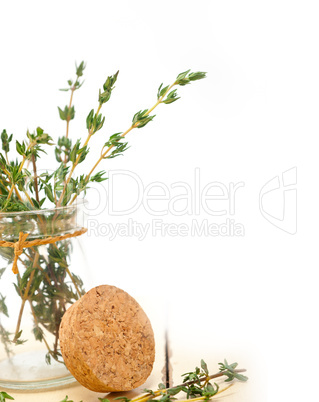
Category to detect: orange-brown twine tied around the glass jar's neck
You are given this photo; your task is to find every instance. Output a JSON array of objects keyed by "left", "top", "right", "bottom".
[{"left": 0, "top": 228, "right": 87, "bottom": 274}]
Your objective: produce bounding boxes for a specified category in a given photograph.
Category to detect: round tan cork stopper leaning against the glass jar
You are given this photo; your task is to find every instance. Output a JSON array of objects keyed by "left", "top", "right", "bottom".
[{"left": 59, "top": 285, "right": 155, "bottom": 392}]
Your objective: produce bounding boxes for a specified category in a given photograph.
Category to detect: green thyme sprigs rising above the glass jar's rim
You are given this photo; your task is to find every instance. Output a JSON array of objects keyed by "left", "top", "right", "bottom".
[{"left": 0, "top": 65, "right": 206, "bottom": 212}]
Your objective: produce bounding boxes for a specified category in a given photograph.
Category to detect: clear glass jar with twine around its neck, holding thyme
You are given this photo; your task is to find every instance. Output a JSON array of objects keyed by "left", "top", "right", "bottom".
[{"left": 0, "top": 203, "right": 89, "bottom": 390}]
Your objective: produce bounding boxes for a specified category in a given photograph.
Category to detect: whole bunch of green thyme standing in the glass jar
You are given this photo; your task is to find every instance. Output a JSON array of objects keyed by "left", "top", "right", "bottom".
[{"left": 0, "top": 61, "right": 206, "bottom": 363}]
